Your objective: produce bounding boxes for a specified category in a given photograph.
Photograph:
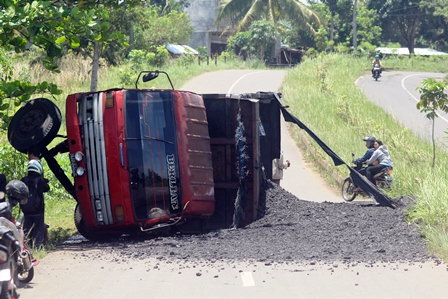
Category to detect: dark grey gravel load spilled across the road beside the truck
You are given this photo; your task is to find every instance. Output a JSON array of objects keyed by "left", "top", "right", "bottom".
[{"left": 66, "top": 183, "right": 434, "bottom": 265}]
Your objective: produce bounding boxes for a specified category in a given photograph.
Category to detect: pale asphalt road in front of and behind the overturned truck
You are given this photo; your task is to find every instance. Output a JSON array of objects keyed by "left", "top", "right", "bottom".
[{"left": 20, "top": 70, "right": 448, "bottom": 299}]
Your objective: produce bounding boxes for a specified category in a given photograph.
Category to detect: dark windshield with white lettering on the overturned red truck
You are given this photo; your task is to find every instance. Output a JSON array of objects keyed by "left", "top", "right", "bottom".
[{"left": 125, "top": 90, "right": 181, "bottom": 220}]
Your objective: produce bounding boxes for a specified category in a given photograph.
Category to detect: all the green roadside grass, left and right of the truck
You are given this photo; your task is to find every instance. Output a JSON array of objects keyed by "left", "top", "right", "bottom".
[{"left": 0, "top": 53, "right": 448, "bottom": 259}]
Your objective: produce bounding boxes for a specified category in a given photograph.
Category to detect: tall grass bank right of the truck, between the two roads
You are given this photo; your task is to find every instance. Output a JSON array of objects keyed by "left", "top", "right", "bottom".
[{"left": 282, "top": 54, "right": 448, "bottom": 260}]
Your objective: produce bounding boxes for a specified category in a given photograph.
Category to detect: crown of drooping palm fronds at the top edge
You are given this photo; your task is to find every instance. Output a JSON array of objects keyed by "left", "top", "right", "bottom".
[{"left": 216, "top": 0, "right": 320, "bottom": 34}]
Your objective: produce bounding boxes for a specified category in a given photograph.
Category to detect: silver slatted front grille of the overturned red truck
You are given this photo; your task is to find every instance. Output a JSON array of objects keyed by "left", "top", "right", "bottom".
[{"left": 78, "top": 93, "right": 113, "bottom": 225}]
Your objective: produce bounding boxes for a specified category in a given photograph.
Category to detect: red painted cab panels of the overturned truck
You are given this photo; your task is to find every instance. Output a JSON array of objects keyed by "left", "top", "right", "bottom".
[{"left": 66, "top": 89, "right": 215, "bottom": 231}]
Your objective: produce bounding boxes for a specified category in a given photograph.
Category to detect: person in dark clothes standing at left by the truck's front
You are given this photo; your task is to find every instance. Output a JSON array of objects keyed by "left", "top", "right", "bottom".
[{"left": 20, "top": 159, "right": 50, "bottom": 247}]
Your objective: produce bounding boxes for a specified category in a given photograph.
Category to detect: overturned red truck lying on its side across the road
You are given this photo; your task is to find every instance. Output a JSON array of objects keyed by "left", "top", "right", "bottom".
[{"left": 8, "top": 71, "right": 282, "bottom": 240}]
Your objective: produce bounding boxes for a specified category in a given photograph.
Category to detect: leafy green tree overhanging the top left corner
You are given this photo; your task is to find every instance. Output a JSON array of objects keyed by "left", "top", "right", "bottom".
[{"left": 0, "top": 0, "right": 141, "bottom": 99}]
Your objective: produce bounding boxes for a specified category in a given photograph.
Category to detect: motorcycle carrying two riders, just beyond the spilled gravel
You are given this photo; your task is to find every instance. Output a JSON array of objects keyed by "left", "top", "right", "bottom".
[{"left": 342, "top": 153, "right": 394, "bottom": 201}]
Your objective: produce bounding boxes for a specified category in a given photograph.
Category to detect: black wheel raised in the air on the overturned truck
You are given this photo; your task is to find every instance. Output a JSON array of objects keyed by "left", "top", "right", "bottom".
[{"left": 8, "top": 98, "right": 62, "bottom": 154}]
